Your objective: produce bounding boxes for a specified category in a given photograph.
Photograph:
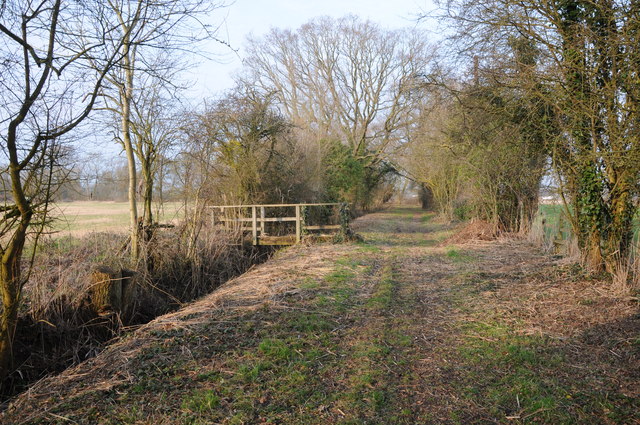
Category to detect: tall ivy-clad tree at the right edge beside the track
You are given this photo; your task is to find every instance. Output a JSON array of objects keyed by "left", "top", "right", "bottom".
[{"left": 436, "top": 0, "right": 640, "bottom": 272}]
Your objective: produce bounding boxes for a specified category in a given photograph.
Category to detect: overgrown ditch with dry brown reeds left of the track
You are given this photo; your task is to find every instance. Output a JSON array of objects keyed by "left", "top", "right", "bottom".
[{"left": 0, "top": 222, "right": 271, "bottom": 398}]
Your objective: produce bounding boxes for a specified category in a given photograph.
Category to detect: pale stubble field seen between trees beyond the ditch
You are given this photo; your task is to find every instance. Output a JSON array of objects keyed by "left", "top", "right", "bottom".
[{"left": 51, "top": 201, "right": 183, "bottom": 236}]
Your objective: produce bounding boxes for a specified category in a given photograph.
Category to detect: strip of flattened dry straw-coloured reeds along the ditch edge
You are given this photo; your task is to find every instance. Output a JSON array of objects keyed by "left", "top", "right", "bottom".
[{"left": 0, "top": 240, "right": 355, "bottom": 423}]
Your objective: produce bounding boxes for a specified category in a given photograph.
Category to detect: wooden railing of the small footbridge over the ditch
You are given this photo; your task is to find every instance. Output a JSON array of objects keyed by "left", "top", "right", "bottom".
[{"left": 210, "top": 203, "right": 341, "bottom": 245}]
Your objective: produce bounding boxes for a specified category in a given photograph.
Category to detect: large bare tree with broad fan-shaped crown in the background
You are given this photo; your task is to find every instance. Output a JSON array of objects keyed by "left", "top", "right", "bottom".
[{"left": 244, "top": 16, "right": 431, "bottom": 207}]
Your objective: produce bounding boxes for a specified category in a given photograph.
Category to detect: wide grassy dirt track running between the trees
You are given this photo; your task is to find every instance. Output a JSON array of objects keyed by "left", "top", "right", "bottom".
[{"left": 0, "top": 208, "right": 640, "bottom": 424}]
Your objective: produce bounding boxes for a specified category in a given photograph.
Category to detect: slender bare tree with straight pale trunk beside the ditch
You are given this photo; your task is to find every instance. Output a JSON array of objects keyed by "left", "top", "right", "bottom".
[{"left": 103, "top": 0, "right": 229, "bottom": 264}]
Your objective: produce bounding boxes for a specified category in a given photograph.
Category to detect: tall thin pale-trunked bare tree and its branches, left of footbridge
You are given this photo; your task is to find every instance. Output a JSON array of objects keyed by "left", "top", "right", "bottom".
[{"left": 95, "top": 0, "right": 228, "bottom": 263}]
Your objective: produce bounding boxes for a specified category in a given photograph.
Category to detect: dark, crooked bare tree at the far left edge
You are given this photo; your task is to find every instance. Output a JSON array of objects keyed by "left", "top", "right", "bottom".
[{"left": 0, "top": 0, "right": 129, "bottom": 376}]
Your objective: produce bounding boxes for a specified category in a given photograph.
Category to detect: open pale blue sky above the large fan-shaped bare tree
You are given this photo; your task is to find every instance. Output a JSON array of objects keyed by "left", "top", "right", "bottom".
[{"left": 189, "top": 0, "right": 435, "bottom": 98}]
